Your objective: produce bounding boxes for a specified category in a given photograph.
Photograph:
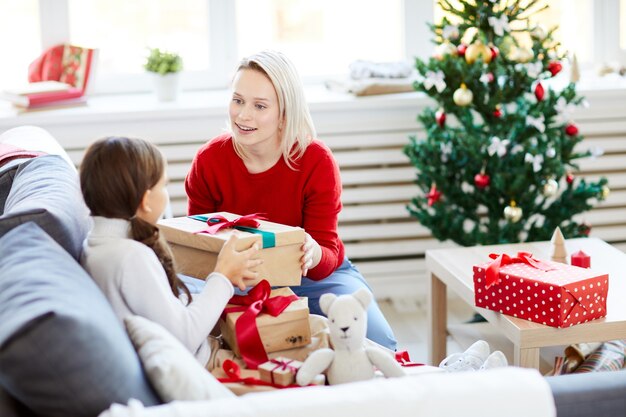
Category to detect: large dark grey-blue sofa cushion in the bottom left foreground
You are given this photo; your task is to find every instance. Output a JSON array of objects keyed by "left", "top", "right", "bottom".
[{"left": 0, "top": 222, "right": 159, "bottom": 416}]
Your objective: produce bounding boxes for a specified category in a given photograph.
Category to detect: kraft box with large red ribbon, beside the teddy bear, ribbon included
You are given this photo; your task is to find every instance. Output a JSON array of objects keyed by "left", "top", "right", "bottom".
[{"left": 220, "top": 281, "right": 311, "bottom": 369}]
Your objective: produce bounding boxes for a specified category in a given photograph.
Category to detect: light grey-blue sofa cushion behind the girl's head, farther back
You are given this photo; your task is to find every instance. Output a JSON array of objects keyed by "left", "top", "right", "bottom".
[{"left": 0, "top": 155, "right": 90, "bottom": 259}]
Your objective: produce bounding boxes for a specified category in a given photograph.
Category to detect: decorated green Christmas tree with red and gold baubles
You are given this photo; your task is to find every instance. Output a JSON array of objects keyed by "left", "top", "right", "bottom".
[{"left": 404, "top": 0, "right": 609, "bottom": 246}]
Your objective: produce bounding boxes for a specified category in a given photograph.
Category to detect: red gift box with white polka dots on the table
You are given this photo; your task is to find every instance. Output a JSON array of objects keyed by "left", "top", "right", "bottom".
[{"left": 474, "top": 252, "right": 609, "bottom": 327}]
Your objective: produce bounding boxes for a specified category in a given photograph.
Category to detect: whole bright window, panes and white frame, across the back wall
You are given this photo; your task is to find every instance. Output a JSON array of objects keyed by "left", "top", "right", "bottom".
[{"left": 0, "top": 0, "right": 626, "bottom": 93}]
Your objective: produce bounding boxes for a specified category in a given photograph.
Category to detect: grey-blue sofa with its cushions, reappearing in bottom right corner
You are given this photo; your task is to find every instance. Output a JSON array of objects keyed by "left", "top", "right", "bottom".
[{"left": 0, "top": 127, "right": 626, "bottom": 417}]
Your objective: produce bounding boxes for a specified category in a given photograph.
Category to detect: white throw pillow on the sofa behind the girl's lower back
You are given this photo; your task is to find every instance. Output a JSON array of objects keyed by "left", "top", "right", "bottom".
[{"left": 124, "top": 316, "right": 234, "bottom": 402}]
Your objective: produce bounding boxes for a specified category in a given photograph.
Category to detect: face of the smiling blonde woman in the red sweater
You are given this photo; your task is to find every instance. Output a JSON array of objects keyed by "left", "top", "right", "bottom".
[{"left": 229, "top": 69, "right": 282, "bottom": 150}]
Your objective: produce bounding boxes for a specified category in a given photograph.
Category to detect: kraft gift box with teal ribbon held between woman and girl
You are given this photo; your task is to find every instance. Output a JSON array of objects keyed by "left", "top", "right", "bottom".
[{"left": 158, "top": 212, "right": 305, "bottom": 287}]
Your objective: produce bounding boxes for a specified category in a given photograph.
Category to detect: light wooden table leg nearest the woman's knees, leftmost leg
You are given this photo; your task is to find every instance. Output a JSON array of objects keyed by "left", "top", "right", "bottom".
[{"left": 428, "top": 274, "right": 448, "bottom": 366}]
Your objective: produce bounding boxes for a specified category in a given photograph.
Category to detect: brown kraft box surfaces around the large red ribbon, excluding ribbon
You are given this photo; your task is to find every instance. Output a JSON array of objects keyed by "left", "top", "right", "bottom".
[{"left": 220, "top": 288, "right": 311, "bottom": 356}]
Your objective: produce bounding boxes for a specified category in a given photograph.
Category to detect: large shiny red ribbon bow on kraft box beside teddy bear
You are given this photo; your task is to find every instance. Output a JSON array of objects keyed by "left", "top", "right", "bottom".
[{"left": 224, "top": 279, "right": 298, "bottom": 369}]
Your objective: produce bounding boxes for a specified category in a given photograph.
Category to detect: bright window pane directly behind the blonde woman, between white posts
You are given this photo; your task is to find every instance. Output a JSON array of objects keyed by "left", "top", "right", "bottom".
[{"left": 236, "top": 0, "right": 405, "bottom": 77}]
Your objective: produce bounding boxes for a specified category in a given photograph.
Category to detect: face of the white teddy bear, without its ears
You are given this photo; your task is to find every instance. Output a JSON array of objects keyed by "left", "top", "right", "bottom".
[{"left": 328, "top": 296, "right": 367, "bottom": 350}]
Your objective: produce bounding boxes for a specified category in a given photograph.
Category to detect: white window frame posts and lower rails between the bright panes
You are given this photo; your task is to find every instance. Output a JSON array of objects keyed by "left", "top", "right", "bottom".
[{"left": 31, "top": 0, "right": 626, "bottom": 94}]
